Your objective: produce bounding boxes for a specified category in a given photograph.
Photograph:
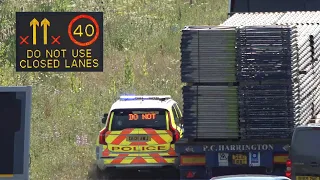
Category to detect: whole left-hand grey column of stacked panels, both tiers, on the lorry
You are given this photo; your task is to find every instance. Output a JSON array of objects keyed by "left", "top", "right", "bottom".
[{"left": 181, "top": 27, "right": 239, "bottom": 138}]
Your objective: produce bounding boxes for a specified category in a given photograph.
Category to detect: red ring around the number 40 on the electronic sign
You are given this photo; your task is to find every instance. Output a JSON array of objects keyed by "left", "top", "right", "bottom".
[{"left": 68, "top": 14, "right": 100, "bottom": 46}]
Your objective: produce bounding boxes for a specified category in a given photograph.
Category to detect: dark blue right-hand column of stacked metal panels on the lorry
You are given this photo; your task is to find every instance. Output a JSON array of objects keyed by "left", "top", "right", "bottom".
[{"left": 236, "top": 26, "right": 298, "bottom": 139}]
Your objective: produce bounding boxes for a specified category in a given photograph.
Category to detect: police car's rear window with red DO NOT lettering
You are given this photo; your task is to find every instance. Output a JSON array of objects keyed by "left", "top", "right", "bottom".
[{"left": 111, "top": 109, "right": 167, "bottom": 131}]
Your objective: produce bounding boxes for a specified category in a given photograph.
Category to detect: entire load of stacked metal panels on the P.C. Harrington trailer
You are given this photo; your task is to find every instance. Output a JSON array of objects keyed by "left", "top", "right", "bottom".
[{"left": 181, "top": 12, "right": 320, "bottom": 139}]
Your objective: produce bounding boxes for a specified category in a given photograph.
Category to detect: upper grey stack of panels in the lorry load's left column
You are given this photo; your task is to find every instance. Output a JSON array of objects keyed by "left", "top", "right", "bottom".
[{"left": 181, "top": 27, "right": 236, "bottom": 83}]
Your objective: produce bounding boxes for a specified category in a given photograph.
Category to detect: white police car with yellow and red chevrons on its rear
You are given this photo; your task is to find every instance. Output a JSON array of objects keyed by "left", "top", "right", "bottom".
[{"left": 96, "top": 95, "right": 183, "bottom": 177}]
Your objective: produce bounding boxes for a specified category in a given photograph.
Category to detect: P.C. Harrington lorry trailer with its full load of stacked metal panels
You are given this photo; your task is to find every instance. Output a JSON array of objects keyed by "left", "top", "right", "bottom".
[{"left": 175, "top": 0, "right": 320, "bottom": 180}]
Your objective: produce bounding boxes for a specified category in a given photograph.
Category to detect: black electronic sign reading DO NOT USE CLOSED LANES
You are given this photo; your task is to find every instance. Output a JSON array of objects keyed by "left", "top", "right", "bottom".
[{"left": 16, "top": 12, "right": 103, "bottom": 72}]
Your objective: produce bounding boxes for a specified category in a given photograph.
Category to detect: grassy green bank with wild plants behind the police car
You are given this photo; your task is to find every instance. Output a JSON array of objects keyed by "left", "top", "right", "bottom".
[{"left": 0, "top": 0, "right": 227, "bottom": 180}]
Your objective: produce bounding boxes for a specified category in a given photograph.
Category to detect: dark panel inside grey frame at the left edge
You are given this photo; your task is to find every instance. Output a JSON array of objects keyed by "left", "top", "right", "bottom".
[{"left": 0, "top": 92, "right": 24, "bottom": 178}]
